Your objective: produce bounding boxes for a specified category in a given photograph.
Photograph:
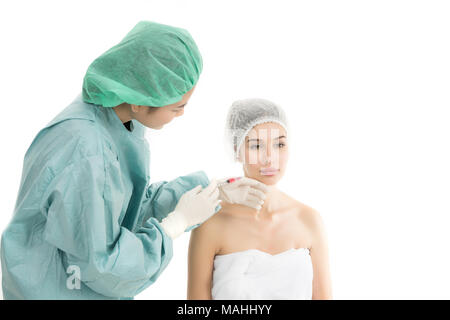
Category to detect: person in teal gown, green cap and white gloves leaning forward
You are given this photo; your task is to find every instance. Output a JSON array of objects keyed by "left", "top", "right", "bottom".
[{"left": 1, "top": 21, "right": 267, "bottom": 299}]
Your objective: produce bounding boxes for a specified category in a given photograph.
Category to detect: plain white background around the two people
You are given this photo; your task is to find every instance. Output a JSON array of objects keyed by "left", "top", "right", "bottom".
[{"left": 0, "top": 0, "right": 450, "bottom": 299}]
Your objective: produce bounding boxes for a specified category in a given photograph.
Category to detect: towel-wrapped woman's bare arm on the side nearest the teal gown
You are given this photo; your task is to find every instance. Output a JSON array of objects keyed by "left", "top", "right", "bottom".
[{"left": 187, "top": 216, "right": 220, "bottom": 300}]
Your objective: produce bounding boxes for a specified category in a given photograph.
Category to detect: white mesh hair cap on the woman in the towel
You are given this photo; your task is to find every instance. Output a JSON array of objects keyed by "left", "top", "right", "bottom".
[{"left": 225, "top": 98, "right": 288, "bottom": 160}]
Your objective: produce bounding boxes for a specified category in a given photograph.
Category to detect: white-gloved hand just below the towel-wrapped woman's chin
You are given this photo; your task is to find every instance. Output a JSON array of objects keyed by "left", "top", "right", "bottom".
[{"left": 218, "top": 177, "right": 268, "bottom": 210}]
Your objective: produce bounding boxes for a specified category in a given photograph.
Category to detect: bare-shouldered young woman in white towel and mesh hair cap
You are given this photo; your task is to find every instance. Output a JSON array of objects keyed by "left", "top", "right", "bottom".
[{"left": 188, "top": 99, "right": 332, "bottom": 299}]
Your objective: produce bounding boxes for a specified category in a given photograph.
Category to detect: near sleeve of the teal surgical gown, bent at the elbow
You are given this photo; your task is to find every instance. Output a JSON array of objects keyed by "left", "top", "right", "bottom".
[{"left": 43, "top": 155, "right": 172, "bottom": 297}]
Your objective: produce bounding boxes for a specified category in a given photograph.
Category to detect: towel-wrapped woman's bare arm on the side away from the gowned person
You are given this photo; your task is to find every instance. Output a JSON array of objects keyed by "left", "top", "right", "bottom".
[{"left": 308, "top": 210, "right": 332, "bottom": 300}]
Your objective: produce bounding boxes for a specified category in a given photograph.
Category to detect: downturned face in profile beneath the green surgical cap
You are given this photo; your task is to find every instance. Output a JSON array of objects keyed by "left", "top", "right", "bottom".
[{"left": 131, "top": 86, "right": 195, "bottom": 129}]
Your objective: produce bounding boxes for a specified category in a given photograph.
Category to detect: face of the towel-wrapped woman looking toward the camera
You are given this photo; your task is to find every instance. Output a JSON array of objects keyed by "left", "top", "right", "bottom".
[{"left": 239, "top": 122, "right": 288, "bottom": 185}]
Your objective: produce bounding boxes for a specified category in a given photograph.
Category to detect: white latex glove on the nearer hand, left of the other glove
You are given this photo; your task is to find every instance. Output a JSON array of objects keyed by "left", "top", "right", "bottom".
[{"left": 161, "top": 179, "right": 220, "bottom": 239}]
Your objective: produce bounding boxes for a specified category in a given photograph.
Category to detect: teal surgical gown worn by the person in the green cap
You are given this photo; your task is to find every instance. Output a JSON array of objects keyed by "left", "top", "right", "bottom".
[{"left": 1, "top": 95, "right": 209, "bottom": 299}]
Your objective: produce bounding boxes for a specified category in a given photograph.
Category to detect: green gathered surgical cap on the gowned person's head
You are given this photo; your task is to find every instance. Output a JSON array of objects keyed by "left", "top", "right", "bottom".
[{"left": 83, "top": 21, "right": 203, "bottom": 107}]
